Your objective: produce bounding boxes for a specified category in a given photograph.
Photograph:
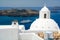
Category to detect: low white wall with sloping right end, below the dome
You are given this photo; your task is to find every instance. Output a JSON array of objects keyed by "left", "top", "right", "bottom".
[{"left": 19, "top": 33, "right": 44, "bottom": 40}]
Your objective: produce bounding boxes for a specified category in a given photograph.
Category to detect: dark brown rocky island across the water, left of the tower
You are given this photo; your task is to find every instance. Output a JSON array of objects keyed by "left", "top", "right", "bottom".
[{"left": 0, "top": 9, "right": 38, "bottom": 16}]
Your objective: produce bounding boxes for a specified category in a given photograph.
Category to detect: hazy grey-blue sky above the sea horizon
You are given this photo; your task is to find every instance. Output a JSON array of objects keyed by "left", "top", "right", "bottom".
[{"left": 0, "top": 0, "right": 60, "bottom": 7}]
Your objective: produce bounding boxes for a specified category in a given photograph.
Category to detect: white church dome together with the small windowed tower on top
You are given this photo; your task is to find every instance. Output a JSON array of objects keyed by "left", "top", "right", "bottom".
[{"left": 30, "top": 6, "right": 59, "bottom": 31}]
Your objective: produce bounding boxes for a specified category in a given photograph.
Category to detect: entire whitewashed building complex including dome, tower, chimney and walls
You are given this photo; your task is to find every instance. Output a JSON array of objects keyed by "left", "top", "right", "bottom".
[{"left": 0, "top": 6, "right": 60, "bottom": 40}]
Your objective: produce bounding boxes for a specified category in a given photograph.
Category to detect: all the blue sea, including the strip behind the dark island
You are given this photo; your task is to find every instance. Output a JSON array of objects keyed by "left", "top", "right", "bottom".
[{"left": 0, "top": 7, "right": 60, "bottom": 29}]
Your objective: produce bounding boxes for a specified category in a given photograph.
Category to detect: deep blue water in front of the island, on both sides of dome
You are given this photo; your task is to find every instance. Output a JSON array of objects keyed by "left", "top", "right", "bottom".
[{"left": 0, "top": 13, "right": 60, "bottom": 29}]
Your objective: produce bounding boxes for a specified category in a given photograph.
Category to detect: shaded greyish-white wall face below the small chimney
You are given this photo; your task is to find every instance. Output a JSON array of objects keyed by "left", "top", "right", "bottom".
[{"left": 0, "top": 28, "right": 18, "bottom": 40}]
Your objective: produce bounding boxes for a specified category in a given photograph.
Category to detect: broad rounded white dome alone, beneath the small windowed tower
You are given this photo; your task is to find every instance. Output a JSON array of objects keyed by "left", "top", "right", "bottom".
[{"left": 30, "top": 19, "right": 59, "bottom": 31}]
